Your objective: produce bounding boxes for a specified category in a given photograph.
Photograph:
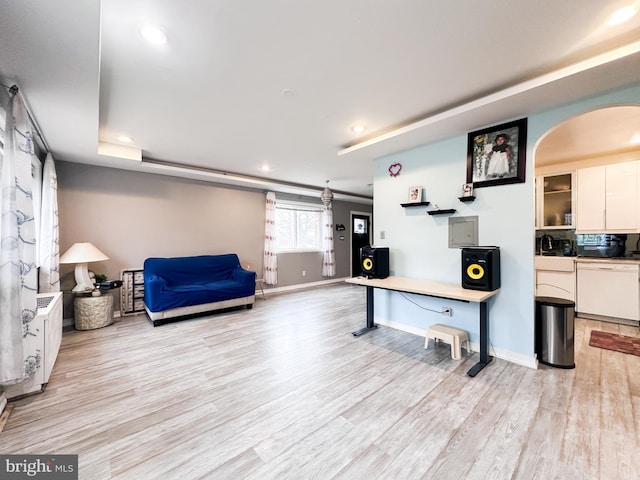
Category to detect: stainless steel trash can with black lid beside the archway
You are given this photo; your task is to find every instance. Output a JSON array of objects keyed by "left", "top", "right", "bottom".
[{"left": 536, "top": 297, "right": 576, "bottom": 368}]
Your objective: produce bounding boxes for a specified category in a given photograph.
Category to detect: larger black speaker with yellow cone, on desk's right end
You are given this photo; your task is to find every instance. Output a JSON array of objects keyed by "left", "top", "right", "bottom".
[{"left": 462, "top": 247, "right": 500, "bottom": 292}]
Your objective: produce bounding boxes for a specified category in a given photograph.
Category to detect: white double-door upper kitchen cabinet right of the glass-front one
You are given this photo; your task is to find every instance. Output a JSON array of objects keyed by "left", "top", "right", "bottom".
[{"left": 576, "top": 161, "right": 639, "bottom": 233}]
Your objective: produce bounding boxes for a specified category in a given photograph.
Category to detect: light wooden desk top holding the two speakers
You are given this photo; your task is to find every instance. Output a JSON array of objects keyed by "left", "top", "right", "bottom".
[{"left": 345, "top": 277, "right": 499, "bottom": 302}]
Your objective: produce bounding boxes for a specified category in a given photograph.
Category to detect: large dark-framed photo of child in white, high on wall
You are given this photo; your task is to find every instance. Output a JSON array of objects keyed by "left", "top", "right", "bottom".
[{"left": 467, "top": 118, "right": 527, "bottom": 188}]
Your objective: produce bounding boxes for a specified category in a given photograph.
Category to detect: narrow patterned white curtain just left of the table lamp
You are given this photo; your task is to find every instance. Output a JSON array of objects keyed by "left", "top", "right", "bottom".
[{"left": 38, "top": 153, "right": 60, "bottom": 293}]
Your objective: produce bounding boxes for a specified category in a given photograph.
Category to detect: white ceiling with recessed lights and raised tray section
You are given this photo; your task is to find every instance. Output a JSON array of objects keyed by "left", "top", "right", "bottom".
[{"left": 0, "top": 0, "right": 640, "bottom": 201}]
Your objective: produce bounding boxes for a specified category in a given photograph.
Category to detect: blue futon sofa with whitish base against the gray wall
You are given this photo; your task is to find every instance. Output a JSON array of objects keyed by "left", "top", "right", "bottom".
[{"left": 144, "top": 253, "right": 256, "bottom": 326}]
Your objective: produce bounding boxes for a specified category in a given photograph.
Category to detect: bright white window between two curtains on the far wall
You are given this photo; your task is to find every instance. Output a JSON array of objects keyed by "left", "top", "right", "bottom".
[{"left": 276, "top": 200, "right": 322, "bottom": 252}]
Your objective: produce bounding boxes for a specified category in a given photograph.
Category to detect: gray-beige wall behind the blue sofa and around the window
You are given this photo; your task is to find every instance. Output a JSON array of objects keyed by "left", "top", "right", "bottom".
[{"left": 56, "top": 161, "right": 372, "bottom": 318}]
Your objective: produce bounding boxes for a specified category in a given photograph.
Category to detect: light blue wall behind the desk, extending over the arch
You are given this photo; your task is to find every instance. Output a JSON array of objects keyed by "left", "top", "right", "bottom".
[{"left": 373, "top": 81, "right": 640, "bottom": 358}]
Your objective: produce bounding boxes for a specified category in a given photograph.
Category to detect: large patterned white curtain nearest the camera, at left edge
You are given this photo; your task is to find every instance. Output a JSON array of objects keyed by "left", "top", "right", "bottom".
[{"left": 0, "top": 89, "right": 41, "bottom": 385}]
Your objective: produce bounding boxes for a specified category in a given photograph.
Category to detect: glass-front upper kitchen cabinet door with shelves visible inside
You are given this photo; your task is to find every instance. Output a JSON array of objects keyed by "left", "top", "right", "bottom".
[{"left": 536, "top": 172, "right": 575, "bottom": 229}]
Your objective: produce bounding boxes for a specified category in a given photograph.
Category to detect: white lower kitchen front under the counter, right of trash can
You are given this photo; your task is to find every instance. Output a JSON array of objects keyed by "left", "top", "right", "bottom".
[{"left": 576, "top": 260, "right": 640, "bottom": 325}]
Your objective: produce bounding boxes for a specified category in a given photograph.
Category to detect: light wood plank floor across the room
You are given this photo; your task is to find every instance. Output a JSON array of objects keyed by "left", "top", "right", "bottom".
[{"left": 0, "top": 285, "right": 640, "bottom": 480}]
